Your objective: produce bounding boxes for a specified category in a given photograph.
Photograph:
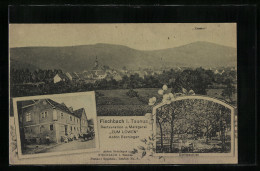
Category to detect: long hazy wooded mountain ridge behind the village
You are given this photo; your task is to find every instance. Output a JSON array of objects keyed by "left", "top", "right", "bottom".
[{"left": 10, "top": 42, "right": 237, "bottom": 72}]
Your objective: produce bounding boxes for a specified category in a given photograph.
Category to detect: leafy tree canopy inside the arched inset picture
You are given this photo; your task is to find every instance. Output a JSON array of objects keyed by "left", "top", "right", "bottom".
[{"left": 157, "top": 99, "right": 231, "bottom": 152}]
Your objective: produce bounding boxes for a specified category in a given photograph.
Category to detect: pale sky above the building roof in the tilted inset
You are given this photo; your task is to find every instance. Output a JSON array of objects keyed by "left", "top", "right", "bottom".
[{"left": 51, "top": 93, "right": 96, "bottom": 119}]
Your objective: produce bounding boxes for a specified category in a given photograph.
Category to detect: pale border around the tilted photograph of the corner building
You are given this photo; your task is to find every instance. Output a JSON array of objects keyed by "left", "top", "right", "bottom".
[{"left": 13, "top": 91, "right": 100, "bottom": 159}]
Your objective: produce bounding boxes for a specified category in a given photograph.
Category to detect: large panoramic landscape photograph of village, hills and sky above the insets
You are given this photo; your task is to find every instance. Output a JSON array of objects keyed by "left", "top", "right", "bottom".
[{"left": 9, "top": 23, "right": 237, "bottom": 116}]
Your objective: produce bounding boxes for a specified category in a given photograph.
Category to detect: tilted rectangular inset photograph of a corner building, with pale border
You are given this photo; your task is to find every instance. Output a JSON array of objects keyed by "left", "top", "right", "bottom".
[{"left": 13, "top": 92, "right": 99, "bottom": 158}]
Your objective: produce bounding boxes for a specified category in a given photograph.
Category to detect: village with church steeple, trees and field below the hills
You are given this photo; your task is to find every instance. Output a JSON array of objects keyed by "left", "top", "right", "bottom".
[{"left": 10, "top": 53, "right": 237, "bottom": 116}]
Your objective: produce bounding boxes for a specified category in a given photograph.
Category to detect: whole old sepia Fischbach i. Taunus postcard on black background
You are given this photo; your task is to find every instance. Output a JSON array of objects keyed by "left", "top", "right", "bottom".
[{"left": 9, "top": 23, "right": 238, "bottom": 164}]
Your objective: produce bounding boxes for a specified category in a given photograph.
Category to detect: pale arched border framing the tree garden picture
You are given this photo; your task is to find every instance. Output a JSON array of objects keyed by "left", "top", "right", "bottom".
[{"left": 152, "top": 95, "right": 237, "bottom": 157}]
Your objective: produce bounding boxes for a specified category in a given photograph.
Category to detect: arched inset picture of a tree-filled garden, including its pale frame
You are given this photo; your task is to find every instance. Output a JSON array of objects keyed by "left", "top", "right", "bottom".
[{"left": 151, "top": 94, "right": 237, "bottom": 156}]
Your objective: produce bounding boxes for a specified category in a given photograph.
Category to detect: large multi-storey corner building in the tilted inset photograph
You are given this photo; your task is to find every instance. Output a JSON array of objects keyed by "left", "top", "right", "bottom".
[{"left": 18, "top": 99, "right": 88, "bottom": 143}]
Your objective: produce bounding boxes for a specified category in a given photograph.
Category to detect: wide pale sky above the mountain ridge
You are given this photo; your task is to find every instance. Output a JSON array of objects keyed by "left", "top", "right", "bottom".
[{"left": 9, "top": 23, "right": 237, "bottom": 50}]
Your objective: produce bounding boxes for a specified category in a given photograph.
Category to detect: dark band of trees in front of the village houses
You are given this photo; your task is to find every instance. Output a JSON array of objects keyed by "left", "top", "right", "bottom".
[{"left": 10, "top": 67, "right": 236, "bottom": 101}]
